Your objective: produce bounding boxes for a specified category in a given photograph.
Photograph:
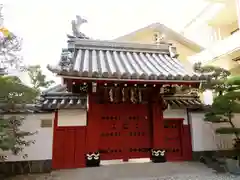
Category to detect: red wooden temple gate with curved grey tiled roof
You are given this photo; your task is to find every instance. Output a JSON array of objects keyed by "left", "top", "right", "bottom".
[{"left": 46, "top": 17, "right": 209, "bottom": 169}]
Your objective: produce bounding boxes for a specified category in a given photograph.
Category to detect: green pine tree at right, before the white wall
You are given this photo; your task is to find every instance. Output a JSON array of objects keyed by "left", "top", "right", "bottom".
[{"left": 194, "top": 63, "right": 240, "bottom": 150}]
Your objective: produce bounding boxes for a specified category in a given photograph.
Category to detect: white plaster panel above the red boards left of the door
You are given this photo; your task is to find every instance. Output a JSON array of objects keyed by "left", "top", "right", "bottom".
[{"left": 58, "top": 109, "right": 87, "bottom": 126}]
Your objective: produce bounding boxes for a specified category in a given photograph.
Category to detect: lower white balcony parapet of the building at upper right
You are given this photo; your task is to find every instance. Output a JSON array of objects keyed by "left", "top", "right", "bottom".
[{"left": 189, "top": 31, "right": 240, "bottom": 64}]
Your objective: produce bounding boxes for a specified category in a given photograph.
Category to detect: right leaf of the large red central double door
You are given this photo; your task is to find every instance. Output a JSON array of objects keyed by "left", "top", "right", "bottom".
[{"left": 123, "top": 104, "right": 151, "bottom": 159}]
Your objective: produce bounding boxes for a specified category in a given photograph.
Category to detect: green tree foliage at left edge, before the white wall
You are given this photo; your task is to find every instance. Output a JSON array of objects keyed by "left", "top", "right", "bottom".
[{"left": 0, "top": 76, "right": 37, "bottom": 160}]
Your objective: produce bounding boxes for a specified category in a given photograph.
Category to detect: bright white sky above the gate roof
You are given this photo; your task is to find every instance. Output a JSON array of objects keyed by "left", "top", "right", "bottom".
[{"left": 0, "top": 0, "right": 207, "bottom": 82}]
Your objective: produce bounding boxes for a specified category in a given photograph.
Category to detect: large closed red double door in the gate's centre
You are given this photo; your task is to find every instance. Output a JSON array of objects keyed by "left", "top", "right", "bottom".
[{"left": 96, "top": 104, "right": 151, "bottom": 160}]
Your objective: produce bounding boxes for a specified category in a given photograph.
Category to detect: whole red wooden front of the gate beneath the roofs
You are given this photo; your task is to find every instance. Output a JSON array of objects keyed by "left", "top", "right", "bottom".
[{"left": 52, "top": 96, "right": 192, "bottom": 169}]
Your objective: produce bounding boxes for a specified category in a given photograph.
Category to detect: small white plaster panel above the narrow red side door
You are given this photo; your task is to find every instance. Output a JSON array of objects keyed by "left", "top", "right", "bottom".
[{"left": 163, "top": 109, "right": 188, "bottom": 125}]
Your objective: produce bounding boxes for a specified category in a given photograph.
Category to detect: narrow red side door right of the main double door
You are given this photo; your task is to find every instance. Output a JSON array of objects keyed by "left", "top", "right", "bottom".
[{"left": 164, "top": 119, "right": 183, "bottom": 161}]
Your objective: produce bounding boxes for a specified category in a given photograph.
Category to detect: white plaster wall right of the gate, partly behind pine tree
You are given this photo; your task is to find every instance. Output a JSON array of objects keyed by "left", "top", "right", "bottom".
[{"left": 190, "top": 113, "right": 240, "bottom": 151}]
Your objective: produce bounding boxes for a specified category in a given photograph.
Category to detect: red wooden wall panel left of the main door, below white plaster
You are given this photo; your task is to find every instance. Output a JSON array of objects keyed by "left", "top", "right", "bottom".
[{"left": 52, "top": 126, "right": 85, "bottom": 169}]
